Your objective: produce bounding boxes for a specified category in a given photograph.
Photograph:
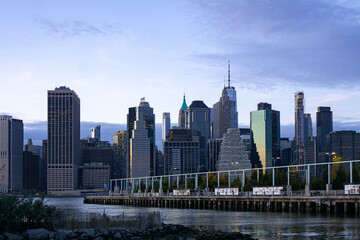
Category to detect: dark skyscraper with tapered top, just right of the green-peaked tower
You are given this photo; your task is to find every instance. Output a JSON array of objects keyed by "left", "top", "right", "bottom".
[{"left": 185, "top": 101, "right": 210, "bottom": 171}]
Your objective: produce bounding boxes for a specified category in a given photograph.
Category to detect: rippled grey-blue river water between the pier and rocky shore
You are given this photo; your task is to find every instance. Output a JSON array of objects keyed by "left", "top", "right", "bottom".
[{"left": 45, "top": 198, "right": 360, "bottom": 239}]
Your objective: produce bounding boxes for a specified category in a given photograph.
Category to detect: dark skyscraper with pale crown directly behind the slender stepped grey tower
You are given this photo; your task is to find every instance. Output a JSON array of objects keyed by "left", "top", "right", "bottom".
[{"left": 127, "top": 98, "right": 156, "bottom": 176}]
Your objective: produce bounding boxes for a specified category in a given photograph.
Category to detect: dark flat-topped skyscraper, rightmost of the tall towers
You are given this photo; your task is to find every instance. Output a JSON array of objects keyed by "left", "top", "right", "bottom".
[{"left": 316, "top": 107, "right": 333, "bottom": 152}]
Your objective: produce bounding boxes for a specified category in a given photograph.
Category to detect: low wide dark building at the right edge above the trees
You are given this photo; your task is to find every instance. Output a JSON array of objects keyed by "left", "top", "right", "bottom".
[{"left": 326, "top": 131, "right": 360, "bottom": 161}]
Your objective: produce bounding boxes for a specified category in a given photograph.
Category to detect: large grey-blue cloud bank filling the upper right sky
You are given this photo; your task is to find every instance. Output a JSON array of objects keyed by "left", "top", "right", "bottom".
[{"left": 195, "top": 0, "right": 360, "bottom": 88}]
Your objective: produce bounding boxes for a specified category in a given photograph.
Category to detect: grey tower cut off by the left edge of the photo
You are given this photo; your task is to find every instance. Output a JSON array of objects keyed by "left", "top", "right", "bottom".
[{"left": 0, "top": 115, "right": 24, "bottom": 192}]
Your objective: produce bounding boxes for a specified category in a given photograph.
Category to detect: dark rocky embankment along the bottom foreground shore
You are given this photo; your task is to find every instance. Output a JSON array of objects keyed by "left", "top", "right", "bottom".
[{"left": 0, "top": 224, "right": 254, "bottom": 240}]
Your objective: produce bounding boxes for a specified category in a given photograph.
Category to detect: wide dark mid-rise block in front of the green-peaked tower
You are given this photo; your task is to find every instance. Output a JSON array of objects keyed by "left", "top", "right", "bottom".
[{"left": 164, "top": 129, "right": 200, "bottom": 175}]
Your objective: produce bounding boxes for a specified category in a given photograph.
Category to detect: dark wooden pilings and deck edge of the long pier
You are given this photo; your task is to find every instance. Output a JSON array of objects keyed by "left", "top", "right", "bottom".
[{"left": 84, "top": 194, "right": 360, "bottom": 215}]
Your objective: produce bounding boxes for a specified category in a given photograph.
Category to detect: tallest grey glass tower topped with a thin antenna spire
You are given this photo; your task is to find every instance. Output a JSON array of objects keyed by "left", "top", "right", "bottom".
[{"left": 212, "top": 61, "right": 238, "bottom": 138}]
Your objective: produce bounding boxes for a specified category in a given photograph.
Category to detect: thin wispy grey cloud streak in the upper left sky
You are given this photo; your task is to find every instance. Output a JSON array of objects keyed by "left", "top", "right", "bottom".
[{"left": 35, "top": 18, "right": 122, "bottom": 38}]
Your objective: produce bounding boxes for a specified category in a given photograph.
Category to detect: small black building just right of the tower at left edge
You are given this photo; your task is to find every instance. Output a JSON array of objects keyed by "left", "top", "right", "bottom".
[{"left": 23, "top": 151, "right": 40, "bottom": 191}]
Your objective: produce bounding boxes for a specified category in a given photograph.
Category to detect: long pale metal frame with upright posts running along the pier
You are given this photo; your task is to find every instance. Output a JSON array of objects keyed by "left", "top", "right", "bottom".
[{"left": 110, "top": 160, "right": 360, "bottom": 194}]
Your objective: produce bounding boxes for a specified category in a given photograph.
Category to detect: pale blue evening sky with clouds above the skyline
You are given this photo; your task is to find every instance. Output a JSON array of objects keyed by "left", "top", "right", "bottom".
[{"left": 0, "top": 0, "right": 360, "bottom": 144}]
